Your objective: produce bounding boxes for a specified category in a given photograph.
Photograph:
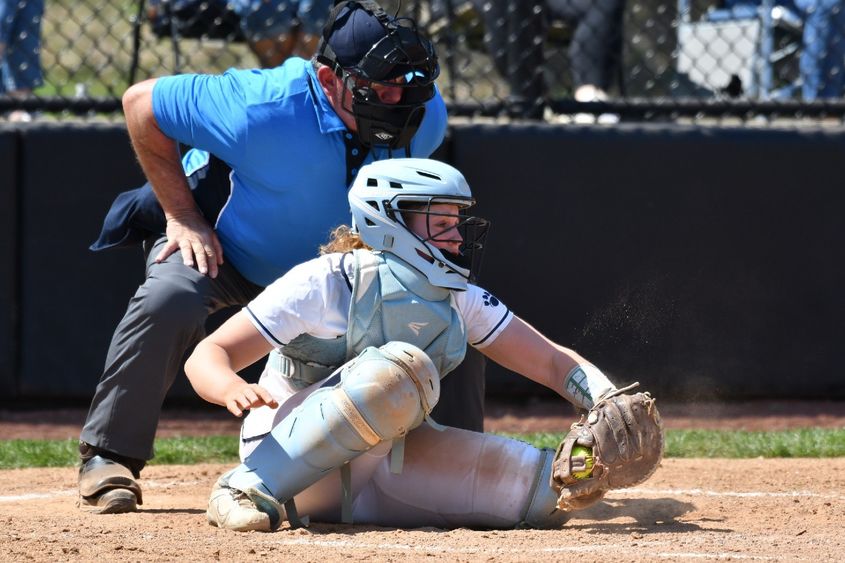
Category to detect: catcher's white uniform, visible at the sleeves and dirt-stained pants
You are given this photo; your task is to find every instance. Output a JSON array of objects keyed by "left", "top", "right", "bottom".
[{"left": 240, "top": 254, "right": 564, "bottom": 527}]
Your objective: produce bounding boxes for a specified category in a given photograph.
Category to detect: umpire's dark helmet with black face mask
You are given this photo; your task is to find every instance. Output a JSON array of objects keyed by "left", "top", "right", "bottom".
[{"left": 315, "top": 0, "right": 440, "bottom": 150}]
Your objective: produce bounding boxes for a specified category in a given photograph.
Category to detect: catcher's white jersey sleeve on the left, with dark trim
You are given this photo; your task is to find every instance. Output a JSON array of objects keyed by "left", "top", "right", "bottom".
[{"left": 244, "top": 257, "right": 349, "bottom": 347}]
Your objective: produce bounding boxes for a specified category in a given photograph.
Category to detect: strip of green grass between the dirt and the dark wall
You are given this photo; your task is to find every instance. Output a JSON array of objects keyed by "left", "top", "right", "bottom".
[{"left": 0, "top": 428, "right": 845, "bottom": 469}]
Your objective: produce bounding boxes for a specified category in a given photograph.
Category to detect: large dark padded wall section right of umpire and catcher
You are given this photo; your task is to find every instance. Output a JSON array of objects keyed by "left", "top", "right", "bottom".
[{"left": 453, "top": 125, "right": 845, "bottom": 399}]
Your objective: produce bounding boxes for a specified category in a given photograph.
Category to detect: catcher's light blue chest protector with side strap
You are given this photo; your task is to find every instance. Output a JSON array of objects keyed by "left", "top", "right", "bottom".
[{"left": 269, "top": 250, "right": 466, "bottom": 388}]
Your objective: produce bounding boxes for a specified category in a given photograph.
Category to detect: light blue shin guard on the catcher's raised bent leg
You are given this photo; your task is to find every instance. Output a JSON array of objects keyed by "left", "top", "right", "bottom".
[{"left": 229, "top": 342, "right": 440, "bottom": 519}]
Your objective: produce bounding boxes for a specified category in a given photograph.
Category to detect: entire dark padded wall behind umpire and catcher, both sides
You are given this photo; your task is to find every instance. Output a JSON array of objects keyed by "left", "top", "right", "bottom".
[{"left": 8, "top": 124, "right": 845, "bottom": 401}]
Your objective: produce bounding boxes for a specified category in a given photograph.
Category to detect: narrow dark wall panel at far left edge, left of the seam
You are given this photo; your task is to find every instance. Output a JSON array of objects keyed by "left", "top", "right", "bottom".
[{"left": 0, "top": 131, "right": 19, "bottom": 399}]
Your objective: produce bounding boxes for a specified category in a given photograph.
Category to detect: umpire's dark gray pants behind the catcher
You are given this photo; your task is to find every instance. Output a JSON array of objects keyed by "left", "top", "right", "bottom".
[{"left": 80, "top": 237, "right": 484, "bottom": 460}]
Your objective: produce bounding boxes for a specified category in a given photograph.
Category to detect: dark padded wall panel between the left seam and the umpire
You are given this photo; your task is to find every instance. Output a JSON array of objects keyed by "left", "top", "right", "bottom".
[{"left": 20, "top": 125, "right": 143, "bottom": 398}]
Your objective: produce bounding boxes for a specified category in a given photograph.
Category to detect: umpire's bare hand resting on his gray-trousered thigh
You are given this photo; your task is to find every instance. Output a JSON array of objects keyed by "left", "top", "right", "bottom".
[{"left": 156, "top": 211, "right": 223, "bottom": 278}]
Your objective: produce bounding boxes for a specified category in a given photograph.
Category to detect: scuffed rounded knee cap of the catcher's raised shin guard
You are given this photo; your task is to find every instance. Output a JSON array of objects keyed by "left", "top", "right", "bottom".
[{"left": 332, "top": 342, "right": 440, "bottom": 445}]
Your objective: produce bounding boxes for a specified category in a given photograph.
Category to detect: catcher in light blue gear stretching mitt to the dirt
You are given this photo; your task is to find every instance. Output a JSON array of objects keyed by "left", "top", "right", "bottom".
[{"left": 185, "top": 159, "right": 663, "bottom": 531}]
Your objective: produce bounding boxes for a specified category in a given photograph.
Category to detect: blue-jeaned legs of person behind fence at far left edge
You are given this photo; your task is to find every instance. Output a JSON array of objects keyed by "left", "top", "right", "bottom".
[{"left": 0, "top": 0, "right": 44, "bottom": 121}]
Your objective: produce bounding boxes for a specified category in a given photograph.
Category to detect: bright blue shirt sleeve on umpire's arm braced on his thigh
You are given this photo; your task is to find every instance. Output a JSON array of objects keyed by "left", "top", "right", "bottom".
[{"left": 153, "top": 70, "right": 247, "bottom": 164}]
